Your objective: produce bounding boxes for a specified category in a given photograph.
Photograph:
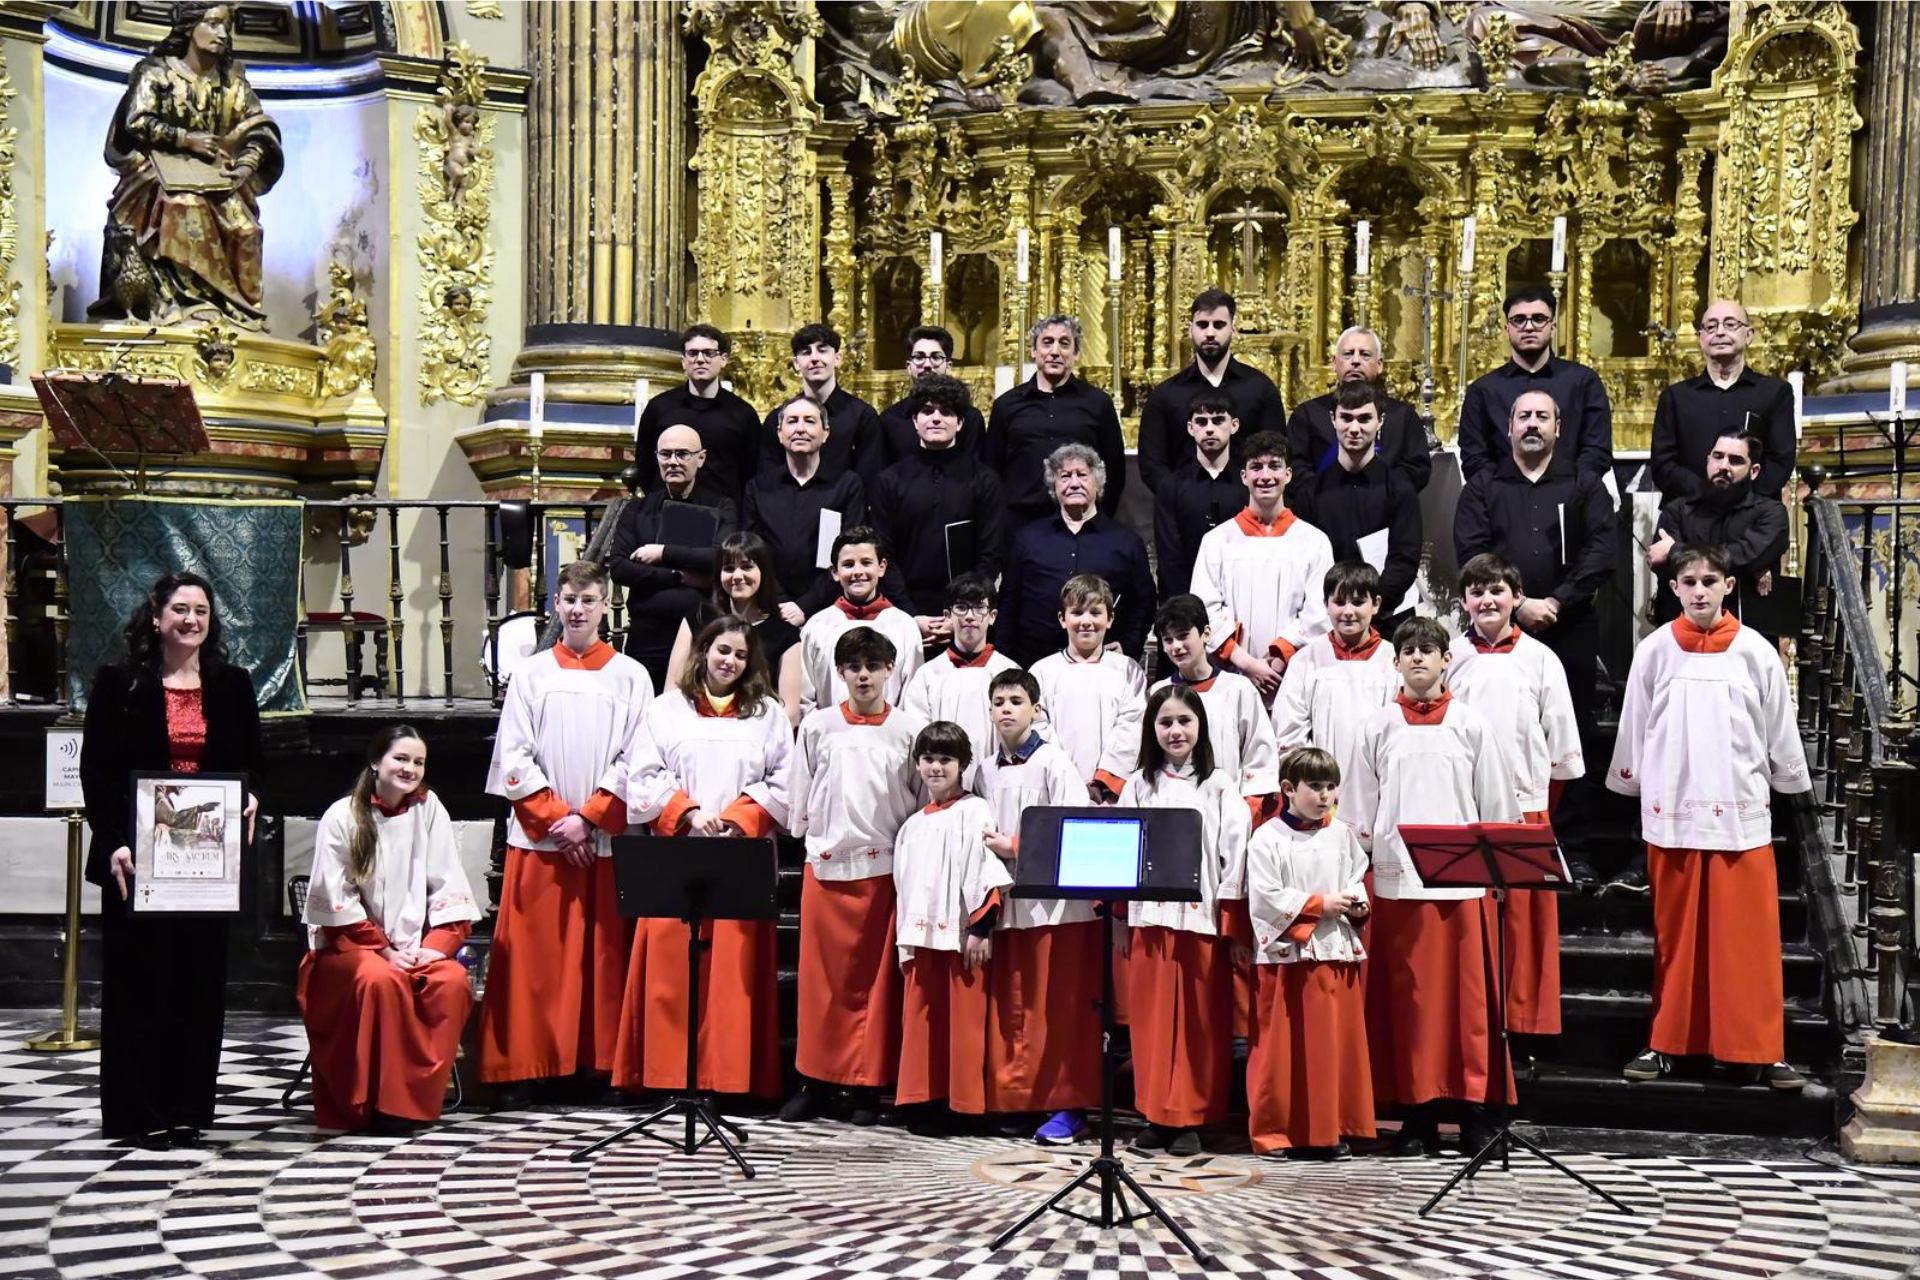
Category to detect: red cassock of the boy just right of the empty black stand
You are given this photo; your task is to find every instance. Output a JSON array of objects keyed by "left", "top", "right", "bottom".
[{"left": 793, "top": 865, "right": 900, "bottom": 1088}]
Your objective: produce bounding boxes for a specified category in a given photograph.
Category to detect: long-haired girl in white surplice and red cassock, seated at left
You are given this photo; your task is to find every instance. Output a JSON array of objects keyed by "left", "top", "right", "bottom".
[{"left": 300, "top": 725, "right": 480, "bottom": 1132}]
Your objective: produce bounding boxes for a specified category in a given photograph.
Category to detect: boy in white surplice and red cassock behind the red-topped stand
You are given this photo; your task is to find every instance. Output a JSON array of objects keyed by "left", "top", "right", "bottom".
[{"left": 1346, "top": 618, "right": 1519, "bottom": 1155}]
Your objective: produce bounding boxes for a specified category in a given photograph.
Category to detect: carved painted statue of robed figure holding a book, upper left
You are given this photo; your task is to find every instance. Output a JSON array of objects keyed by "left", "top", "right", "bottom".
[{"left": 88, "top": 4, "right": 284, "bottom": 330}]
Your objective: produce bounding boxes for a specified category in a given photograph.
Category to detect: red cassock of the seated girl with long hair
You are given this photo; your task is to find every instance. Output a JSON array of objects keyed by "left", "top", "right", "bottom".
[{"left": 298, "top": 921, "right": 472, "bottom": 1130}]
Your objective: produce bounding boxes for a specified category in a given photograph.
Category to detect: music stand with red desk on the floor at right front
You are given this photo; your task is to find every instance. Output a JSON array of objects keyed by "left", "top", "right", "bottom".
[{"left": 1398, "top": 821, "right": 1632, "bottom": 1217}]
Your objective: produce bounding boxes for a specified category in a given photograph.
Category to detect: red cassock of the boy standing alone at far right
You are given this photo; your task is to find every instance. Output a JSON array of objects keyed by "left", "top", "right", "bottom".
[{"left": 1647, "top": 844, "right": 1786, "bottom": 1063}]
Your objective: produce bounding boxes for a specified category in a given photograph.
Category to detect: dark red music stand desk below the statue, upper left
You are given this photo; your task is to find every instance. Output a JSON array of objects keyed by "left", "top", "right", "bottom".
[{"left": 33, "top": 370, "right": 213, "bottom": 493}]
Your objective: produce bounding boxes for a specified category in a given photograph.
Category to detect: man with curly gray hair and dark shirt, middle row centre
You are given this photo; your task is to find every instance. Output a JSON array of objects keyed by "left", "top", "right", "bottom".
[{"left": 989, "top": 436, "right": 1154, "bottom": 666}]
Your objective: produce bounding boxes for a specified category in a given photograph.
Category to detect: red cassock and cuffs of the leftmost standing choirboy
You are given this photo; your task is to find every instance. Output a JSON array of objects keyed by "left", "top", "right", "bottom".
[{"left": 480, "top": 791, "right": 634, "bottom": 1082}]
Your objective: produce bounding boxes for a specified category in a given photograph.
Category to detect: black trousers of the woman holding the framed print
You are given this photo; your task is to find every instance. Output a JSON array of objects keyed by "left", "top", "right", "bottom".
[{"left": 100, "top": 905, "right": 227, "bottom": 1138}]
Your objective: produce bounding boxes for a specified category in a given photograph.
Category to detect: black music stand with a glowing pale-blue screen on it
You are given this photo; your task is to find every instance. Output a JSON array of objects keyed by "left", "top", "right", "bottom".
[{"left": 993, "top": 806, "right": 1213, "bottom": 1267}]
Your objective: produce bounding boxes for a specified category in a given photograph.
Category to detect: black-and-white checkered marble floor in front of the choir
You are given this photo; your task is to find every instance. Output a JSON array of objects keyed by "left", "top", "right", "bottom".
[{"left": 0, "top": 1013, "right": 1920, "bottom": 1280}]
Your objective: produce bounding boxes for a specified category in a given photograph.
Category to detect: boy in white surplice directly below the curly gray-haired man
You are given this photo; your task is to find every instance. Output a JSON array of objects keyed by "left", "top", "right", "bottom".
[{"left": 1033, "top": 574, "right": 1146, "bottom": 804}]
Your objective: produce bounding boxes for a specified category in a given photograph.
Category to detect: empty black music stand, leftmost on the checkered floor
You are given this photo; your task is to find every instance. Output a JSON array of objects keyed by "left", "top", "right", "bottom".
[{"left": 568, "top": 835, "right": 780, "bottom": 1178}]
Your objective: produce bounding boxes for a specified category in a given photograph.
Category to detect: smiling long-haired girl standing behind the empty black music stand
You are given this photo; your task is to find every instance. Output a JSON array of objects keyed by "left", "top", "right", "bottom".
[{"left": 612, "top": 614, "right": 793, "bottom": 1098}]
